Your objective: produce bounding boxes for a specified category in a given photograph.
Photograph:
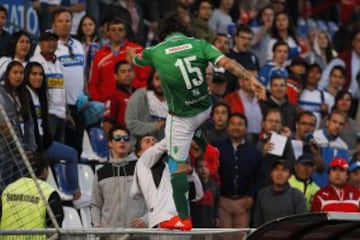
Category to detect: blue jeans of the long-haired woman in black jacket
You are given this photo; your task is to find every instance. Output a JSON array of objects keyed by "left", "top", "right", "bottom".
[{"left": 47, "top": 141, "right": 80, "bottom": 193}]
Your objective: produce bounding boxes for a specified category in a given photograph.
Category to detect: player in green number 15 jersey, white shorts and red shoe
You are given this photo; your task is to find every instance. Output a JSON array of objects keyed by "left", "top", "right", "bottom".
[{"left": 127, "top": 14, "right": 265, "bottom": 231}]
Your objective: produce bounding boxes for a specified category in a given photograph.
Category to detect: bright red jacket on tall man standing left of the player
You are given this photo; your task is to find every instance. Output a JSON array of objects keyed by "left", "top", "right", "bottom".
[{"left": 89, "top": 40, "right": 151, "bottom": 102}]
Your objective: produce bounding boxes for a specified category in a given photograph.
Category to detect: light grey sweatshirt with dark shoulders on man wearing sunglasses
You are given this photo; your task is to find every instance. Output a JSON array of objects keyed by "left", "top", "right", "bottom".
[{"left": 91, "top": 153, "right": 147, "bottom": 228}]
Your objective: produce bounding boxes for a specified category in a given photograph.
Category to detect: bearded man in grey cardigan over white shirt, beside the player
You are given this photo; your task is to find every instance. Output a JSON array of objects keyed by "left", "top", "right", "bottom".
[{"left": 125, "top": 71, "right": 168, "bottom": 149}]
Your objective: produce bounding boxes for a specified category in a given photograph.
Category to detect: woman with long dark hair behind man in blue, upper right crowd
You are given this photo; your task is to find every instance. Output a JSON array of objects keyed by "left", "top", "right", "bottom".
[{"left": 267, "top": 12, "right": 300, "bottom": 61}]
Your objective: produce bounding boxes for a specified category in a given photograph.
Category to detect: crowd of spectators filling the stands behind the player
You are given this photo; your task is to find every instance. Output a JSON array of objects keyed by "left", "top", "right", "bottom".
[{"left": 0, "top": 0, "right": 360, "bottom": 231}]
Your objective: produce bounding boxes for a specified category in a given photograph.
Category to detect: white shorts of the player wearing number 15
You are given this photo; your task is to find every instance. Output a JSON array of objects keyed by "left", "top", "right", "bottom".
[{"left": 165, "top": 107, "right": 211, "bottom": 162}]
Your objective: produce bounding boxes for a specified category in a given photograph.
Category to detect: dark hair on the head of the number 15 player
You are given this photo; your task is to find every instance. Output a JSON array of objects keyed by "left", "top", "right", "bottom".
[{"left": 158, "top": 13, "right": 190, "bottom": 41}]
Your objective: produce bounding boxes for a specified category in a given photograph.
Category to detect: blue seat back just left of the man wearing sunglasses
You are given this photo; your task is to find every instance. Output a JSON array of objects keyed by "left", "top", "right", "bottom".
[{"left": 89, "top": 128, "right": 109, "bottom": 158}]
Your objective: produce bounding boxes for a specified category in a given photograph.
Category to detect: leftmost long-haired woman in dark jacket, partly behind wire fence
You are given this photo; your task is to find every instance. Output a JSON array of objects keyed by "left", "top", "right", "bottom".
[{"left": 0, "top": 61, "right": 37, "bottom": 192}]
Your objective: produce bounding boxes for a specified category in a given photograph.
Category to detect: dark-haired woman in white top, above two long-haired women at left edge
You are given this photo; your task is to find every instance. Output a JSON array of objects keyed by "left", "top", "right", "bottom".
[{"left": 0, "top": 31, "right": 31, "bottom": 84}]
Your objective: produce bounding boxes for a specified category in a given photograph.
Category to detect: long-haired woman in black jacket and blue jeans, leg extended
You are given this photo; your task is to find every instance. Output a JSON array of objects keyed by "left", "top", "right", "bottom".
[{"left": 24, "top": 62, "right": 90, "bottom": 208}]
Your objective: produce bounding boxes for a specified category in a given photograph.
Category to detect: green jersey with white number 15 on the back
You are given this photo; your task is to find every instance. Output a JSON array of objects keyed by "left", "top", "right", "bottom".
[{"left": 134, "top": 33, "right": 223, "bottom": 117}]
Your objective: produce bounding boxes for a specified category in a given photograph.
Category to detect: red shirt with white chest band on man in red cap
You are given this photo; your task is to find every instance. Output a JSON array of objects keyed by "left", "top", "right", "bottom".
[{"left": 311, "top": 183, "right": 360, "bottom": 212}]
